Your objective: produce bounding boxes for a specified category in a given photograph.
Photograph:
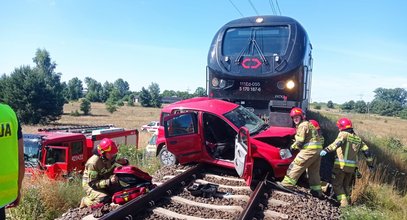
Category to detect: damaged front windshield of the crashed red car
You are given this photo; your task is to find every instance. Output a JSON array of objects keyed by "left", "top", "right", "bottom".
[{"left": 224, "top": 106, "right": 265, "bottom": 134}]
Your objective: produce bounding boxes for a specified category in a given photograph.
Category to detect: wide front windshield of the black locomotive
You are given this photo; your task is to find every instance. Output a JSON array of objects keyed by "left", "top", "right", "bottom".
[{"left": 222, "top": 26, "right": 290, "bottom": 56}]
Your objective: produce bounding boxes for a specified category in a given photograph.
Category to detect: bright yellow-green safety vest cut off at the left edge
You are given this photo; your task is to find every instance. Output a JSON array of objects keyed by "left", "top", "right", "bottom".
[{"left": 0, "top": 104, "right": 18, "bottom": 207}]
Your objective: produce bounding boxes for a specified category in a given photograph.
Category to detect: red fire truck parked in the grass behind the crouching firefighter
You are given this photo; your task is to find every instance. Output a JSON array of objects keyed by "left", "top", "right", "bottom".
[{"left": 23, "top": 125, "right": 138, "bottom": 179}]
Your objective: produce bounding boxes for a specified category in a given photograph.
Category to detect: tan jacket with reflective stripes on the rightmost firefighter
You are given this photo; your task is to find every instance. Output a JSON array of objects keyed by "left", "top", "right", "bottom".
[{"left": 324, "top": 131, "right": 373, "bottom": 173}]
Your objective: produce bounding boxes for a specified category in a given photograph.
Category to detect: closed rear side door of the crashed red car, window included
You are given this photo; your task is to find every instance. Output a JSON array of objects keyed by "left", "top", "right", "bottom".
[{"left": 164, "top": 112, "right": 202, "bottom": 164}]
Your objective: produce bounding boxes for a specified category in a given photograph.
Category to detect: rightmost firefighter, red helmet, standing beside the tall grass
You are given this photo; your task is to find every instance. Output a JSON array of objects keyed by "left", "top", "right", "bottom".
[{"left": 320, "top": 118, "right": 373, "bottom": 207}]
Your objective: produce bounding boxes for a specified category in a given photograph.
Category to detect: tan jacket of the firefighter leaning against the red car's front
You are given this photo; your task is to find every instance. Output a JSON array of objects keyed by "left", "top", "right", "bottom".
[{"left": 291, "top": 120, "right": 322, "bottom": 150}]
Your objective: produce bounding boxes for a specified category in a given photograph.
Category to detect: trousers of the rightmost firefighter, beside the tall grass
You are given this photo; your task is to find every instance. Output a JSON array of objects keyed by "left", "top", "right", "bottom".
[{"left": 332, "top": 166, "right": 354, "bottom": 207}]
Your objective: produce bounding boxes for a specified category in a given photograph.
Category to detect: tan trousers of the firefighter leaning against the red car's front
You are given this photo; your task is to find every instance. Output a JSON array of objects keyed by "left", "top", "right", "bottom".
[{"left": 282, "top": 149, "right": 321, "bottom": 192}]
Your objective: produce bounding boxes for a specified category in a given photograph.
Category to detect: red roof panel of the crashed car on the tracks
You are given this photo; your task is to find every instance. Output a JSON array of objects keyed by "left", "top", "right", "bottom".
[{"left": 163, "top": 97, "right": 239, "bottom": 115}]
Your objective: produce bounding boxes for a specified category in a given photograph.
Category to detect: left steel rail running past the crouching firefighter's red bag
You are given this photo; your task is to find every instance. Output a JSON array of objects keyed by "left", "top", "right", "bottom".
[{"left": 100, "top": 164, "right": 205, "bottom": 220}]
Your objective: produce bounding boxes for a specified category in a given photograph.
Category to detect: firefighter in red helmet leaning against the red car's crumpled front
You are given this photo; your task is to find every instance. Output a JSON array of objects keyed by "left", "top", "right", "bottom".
[{"left": 281, "top": 108, "right": 322, "bottom": 198}]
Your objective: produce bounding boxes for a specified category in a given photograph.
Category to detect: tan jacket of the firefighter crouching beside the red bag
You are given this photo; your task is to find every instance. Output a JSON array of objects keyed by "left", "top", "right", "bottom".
[{"left": 82, "top": 155, "right": 115, "bottom": 190}]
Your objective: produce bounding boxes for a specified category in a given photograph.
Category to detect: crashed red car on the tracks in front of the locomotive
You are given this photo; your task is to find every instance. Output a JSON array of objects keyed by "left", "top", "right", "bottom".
[{"left": 157, "top": 97, "right": 295, "bottom": 185}]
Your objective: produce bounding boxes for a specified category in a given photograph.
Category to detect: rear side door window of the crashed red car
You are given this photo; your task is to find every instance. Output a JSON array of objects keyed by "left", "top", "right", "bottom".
[{"left": 168, "top": 114, "right": 196, "bottom": 136}]
